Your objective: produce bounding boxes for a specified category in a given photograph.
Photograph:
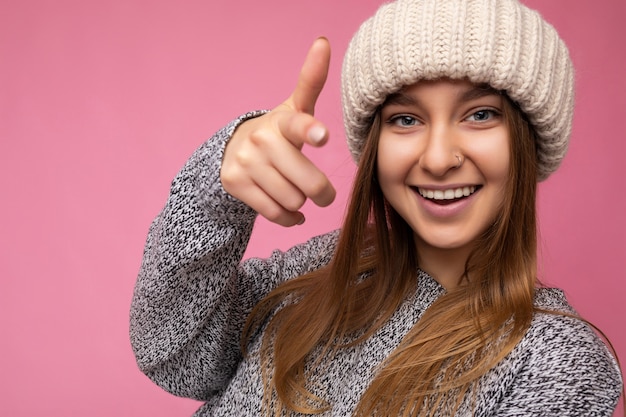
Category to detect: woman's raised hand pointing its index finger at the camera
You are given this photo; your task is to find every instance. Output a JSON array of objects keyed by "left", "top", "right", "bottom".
[{"left": 220, "top": 38, "right": 335, "bottom": 226}]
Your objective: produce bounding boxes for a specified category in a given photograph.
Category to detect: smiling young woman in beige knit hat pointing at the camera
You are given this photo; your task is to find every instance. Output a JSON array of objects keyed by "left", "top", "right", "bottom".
[{"left": 131, "top": 0, "right": 622, "bottom": 416}]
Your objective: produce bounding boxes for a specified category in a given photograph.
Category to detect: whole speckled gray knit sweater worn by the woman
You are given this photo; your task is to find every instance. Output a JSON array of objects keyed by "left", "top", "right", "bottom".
[{"left": 130, "top": 113, "right": 622, "bottom": 417}]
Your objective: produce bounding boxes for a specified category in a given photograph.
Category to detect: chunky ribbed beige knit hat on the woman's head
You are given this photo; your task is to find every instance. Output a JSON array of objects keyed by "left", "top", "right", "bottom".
[{"left": 342, "top": 0, "right": 574, "bottom": 181}]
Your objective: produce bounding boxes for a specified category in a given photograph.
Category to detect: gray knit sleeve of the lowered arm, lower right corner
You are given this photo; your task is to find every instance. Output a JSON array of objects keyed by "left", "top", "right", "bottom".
[{"left": 496, "top": 313, "right": 622, "bottom": 417}]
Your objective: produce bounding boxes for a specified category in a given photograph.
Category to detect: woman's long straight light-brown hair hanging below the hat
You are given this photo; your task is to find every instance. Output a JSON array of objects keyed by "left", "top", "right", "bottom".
[{"left": 242, "top": 91, "right": 537, "bottom": 416}]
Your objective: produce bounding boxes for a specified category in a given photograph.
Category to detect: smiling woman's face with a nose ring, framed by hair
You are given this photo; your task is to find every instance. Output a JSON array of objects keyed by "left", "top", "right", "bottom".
[{"left": 377, "top": 80, "right": 511, "bottom": 262}]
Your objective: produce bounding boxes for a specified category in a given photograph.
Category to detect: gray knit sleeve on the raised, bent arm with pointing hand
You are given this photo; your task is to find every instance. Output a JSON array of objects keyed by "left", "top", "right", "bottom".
[{"left": 130, "top": 112, "right": 336, "bottom": 401}]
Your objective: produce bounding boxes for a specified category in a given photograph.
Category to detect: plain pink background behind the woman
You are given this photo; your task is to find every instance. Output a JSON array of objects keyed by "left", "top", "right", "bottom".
[{"left": 0, "top": 0, "right": 626, "bottom": 417}]
